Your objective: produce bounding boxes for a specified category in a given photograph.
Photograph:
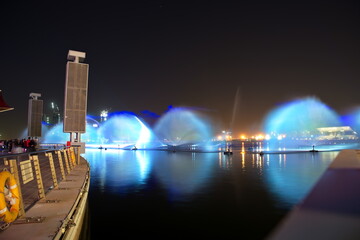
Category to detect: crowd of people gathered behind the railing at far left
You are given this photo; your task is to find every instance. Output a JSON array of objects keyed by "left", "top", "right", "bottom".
[{"left": 0, "top": 137, "right": 37, "bottom": 153}]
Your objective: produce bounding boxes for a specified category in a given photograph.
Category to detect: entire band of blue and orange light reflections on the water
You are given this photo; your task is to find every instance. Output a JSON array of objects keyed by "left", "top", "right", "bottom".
[{"left": 86, "top": 149, "right": 338, "bottom": 207}]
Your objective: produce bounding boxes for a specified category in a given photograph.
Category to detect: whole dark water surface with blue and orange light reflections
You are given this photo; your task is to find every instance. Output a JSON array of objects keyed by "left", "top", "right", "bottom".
[{"left": 84, "top": 149, "right": 338, "bottom": 239}]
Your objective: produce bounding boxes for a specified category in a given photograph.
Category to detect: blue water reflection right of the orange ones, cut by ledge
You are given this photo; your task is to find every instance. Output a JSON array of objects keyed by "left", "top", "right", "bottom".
[{"left": 264, "top": 152, "right": 338, "bottom": 208}]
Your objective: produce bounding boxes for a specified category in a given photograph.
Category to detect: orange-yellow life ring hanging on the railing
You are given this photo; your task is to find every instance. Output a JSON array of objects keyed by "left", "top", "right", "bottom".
[{"left": 0, "top": 171, "right": 20, "bottom": 223}]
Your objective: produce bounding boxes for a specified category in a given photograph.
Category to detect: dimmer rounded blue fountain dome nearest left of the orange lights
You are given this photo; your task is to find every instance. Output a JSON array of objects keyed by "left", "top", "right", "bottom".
[{"left": 154, "top": 107, "right": 212, "bottom": 150}]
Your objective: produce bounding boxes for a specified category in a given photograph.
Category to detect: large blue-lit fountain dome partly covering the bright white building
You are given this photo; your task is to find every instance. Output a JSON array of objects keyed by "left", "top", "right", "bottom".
[{"left": 264, "top": 97, "right": 352, "bottom": 150}]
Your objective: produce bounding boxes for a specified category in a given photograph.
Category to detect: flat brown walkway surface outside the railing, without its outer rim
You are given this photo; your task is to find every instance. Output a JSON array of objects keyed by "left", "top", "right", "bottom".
[{"left": 0, "top": 159, "right": 89, "bottom": 240}]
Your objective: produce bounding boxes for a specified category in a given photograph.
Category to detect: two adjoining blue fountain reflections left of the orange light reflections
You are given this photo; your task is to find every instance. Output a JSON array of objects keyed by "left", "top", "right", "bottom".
[{"left": 85, "top": 149, "right": 216, "bottom": 198}]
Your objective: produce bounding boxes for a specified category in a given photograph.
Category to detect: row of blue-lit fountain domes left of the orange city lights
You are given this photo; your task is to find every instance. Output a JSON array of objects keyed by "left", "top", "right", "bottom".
[{"left": 42, "top": 108, "right": 217, "bottom": 151}]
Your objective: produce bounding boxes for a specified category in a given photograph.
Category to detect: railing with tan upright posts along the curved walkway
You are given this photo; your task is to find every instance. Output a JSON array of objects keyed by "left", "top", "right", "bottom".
[{"left": 0, "top": 147, "right": 80, "bottom": 225}]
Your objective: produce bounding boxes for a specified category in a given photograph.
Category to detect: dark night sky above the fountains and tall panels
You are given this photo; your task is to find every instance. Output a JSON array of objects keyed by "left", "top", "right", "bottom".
[{"left": 0, "top": 0, "right": 360, "bottom": 137}]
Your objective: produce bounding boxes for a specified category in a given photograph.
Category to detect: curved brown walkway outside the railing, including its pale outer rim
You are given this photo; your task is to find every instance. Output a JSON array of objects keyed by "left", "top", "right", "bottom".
[{"left": 0, "top": 148, "right": 90, "bottom": 240}]
